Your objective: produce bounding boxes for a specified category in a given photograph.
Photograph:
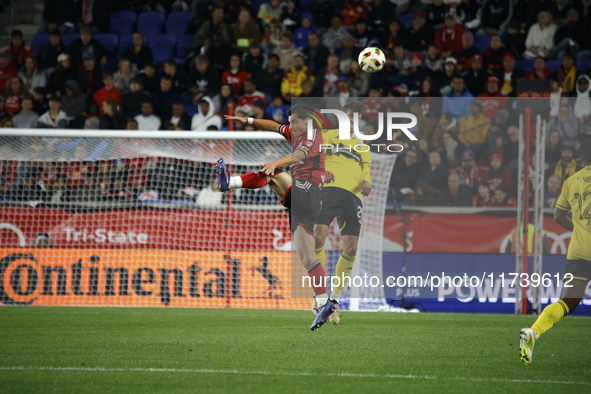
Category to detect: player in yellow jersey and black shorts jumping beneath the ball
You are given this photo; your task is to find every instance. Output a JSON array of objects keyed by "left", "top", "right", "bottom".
[{"left": 312, "top": 101, "right": 371, "bottom": 324}]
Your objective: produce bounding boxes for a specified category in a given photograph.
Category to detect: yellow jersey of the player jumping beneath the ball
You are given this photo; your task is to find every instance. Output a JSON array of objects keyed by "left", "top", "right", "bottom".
[{"left": 322, "top": 129, "right": 371, "bottom": 199}]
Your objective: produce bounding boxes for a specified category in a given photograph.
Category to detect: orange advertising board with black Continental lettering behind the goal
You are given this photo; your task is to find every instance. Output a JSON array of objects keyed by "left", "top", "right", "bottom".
[{"left": 0, "top": 248, "right": 311, "bottom": 309}]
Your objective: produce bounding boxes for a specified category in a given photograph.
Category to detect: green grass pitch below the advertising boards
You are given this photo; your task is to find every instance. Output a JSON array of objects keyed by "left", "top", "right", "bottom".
[{"left": 0, "top": 307, "right": 591, "bottom": 394}]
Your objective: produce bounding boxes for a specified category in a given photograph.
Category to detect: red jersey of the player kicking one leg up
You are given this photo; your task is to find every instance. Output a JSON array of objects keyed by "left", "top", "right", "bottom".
[{"left": 279, "top": 125, "right": 325, "bottom": 188}]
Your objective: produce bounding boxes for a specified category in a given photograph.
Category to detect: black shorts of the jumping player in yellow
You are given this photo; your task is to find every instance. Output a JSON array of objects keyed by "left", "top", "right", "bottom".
[{"left": 317, "top": 187, "right": 363, "bottom": 237}]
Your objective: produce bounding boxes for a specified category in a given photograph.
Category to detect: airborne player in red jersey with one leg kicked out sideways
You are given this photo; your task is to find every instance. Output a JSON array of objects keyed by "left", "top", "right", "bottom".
[{"left": 217, "top": 108, "right": 335, "bottom": 330}]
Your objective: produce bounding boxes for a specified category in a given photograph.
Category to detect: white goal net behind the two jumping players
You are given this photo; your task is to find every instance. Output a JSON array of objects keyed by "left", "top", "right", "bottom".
[{"left": 0, "top": 129, "right": 393, "bottom": 309}]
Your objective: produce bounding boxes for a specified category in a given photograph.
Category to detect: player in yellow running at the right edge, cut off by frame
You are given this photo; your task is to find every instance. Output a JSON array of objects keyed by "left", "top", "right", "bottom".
[{"left": 519, "top": 141, "right": 591, "bottom": 365}]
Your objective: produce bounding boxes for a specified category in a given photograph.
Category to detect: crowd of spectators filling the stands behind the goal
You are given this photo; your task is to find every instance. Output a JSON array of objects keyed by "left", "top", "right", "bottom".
[{"left": 0, "top": 0, "right": 591, "bottom": 207}]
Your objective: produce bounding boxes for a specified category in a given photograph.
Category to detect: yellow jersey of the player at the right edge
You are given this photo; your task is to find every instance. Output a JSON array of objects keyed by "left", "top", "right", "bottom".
[{"left": 556, "top": 166, "right": 591, "bottom": 261}]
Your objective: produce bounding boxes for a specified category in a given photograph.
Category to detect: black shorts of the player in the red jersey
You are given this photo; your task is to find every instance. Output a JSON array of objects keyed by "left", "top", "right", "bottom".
[{"left": 281, "top": 180, "right": 321, "bottom": 236}]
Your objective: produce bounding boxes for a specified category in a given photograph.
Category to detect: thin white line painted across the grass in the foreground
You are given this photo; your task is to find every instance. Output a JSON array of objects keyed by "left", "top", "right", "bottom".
[{"left": 0, "top": 366, "right": 591, "bottom": 386}]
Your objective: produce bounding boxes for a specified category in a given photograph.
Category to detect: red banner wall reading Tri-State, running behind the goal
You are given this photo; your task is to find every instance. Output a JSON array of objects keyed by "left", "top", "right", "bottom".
[{"left": 0, "top": 208, "right": 571, "bottom": 254}]
